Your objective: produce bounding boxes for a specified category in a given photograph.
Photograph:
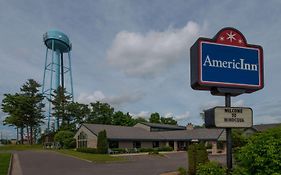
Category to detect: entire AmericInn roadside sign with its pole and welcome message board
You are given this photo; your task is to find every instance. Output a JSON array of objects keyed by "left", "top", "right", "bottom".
[{"left": 190, "top": 27, "right": 264, "bottom": 174}]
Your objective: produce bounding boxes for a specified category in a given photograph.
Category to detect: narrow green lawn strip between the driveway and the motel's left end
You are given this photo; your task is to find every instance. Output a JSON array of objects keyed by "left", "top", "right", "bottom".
[{"left": 56, "top": 149, "right": 126, "bottom": 163}]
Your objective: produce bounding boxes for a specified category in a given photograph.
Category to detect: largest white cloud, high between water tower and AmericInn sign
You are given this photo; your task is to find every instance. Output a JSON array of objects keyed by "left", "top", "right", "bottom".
[{"left": 107, "top": 21, "right": 200, "bottom": 77}]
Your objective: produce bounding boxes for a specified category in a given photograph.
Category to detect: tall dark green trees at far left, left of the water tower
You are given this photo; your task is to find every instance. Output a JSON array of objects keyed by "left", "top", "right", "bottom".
[{"left": 2, "top": 79, "right": 44, "bottom": 144}]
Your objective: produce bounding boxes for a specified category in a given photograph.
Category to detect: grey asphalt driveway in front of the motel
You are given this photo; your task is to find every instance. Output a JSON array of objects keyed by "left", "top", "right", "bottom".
[{"left": 12, "top": 151, "right": 225, "bottom": 175}]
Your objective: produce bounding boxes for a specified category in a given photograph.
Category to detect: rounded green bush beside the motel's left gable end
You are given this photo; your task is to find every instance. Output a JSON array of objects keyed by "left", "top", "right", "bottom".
[{"left": 54, "top": 131, "right": 76, "bottom": 149}]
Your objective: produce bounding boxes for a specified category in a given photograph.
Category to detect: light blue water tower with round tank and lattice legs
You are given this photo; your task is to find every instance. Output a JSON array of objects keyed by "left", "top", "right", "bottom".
[{"left": 42, "top": 30, "right": 73, "bottom": 131}]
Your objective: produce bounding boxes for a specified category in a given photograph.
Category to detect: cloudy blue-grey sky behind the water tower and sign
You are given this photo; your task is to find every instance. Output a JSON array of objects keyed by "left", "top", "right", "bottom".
[{"left": 0, "top": 0, "right": 281, "bottom": 138}]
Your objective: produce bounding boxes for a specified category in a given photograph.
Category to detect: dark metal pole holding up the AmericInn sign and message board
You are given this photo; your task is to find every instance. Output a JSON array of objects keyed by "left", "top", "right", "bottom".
[{"left": 225, "top": 94, "right": 232, "bottom": 175}]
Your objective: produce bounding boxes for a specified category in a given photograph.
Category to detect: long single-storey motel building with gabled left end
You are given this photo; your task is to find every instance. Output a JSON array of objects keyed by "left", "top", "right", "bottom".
[{"left": 74, "top": 123, "right": 226, "bottom": 154}]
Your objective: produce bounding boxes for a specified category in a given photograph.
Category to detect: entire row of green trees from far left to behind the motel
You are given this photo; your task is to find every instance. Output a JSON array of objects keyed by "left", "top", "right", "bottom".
[{"left": 2, "top": 79, "right": 177, "bottom": 144}]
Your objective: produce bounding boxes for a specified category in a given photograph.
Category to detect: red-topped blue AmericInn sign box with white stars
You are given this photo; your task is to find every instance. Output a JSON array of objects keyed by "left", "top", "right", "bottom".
[{"left": 190, "top": 28, "right": 263, "bottom": 93}]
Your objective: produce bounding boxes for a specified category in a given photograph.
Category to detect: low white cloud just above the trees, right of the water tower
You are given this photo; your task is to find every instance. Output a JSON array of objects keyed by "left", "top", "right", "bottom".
[{"left": 78, "top": 91, "right": 144, "bottom": 106}]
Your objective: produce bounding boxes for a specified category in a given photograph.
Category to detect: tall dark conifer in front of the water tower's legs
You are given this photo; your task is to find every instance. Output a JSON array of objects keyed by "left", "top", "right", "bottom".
[{"left": 49, "top": 86, "right": 72, "bottom": 130}]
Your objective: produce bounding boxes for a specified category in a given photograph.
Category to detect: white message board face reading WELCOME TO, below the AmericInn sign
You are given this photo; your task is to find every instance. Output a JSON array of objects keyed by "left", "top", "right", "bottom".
[{"left": 214, "top": 107, "right": 253, "bottom": 128}]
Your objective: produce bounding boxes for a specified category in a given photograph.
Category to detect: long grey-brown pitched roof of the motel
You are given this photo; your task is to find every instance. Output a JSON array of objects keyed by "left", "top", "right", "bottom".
[{"left": 83, "top": 124, "right": 223, "bottom": 141}]
